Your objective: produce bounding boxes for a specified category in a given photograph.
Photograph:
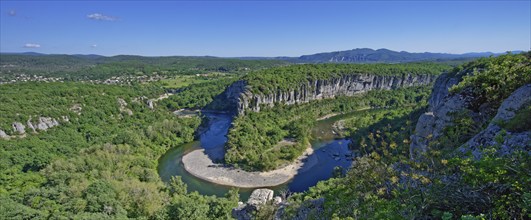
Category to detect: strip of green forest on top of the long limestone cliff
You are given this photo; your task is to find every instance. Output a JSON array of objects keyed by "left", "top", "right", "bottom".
[{"left": 243, "top": 63, "right": 451, "bottom": 94}]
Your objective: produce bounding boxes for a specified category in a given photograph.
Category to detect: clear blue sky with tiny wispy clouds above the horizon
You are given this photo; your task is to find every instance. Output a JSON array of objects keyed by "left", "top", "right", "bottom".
[{"left": 0, "top": 0, "right": 531, "bottom": 57}]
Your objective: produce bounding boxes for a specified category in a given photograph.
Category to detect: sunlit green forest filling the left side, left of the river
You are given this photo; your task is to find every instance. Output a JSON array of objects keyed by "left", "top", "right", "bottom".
[{"left": 0, "top": 83, "right": 238, "bottom": 219}]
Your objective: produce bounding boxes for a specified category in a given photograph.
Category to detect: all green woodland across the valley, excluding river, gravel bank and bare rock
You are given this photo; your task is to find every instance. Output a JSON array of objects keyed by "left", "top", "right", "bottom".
[{"left": 0, "top": 53, "right": 531, "bottom": 219}]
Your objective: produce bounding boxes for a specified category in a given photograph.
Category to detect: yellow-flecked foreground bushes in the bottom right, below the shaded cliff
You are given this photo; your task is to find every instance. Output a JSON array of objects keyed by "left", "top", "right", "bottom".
[{"left": 285, "top": 113, "right": 531, "bottom": 219}]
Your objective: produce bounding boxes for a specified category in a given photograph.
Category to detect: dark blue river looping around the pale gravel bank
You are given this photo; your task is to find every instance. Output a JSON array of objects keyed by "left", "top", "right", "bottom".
[{"left": 158, "top": 113, "right": 358, "bottom": 201}]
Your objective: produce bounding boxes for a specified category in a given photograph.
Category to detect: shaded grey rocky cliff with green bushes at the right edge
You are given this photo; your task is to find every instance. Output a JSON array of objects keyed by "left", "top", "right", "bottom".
[{"left": 410, "top": 53, "right": 531, "bottom": 159}]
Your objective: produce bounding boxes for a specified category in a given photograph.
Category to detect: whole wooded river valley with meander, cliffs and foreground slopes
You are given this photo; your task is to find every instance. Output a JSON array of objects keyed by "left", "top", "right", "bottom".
[{"left": 0, "top": 53, "right": 531, "bottom": 219}]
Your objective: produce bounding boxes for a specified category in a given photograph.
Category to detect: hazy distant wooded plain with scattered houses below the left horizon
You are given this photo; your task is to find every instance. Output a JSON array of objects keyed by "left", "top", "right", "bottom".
[{"left": 0, "top": 54, "right": 288, "bottom": 82}]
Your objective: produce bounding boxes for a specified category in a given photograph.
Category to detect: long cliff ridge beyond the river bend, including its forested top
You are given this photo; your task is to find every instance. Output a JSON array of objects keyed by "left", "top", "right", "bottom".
[{"left": 219, "top": 64, "right": 448, "bottom": 115}]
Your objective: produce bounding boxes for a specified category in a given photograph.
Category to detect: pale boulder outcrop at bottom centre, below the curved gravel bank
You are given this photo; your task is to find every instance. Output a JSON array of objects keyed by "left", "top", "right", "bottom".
[{"left": 232, "top": 189, "right": 274, "bottom": 220}]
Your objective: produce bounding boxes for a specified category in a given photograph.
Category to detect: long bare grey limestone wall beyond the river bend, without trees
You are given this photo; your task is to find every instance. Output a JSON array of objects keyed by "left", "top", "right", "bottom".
[{"left": 221, "top": 74, "right": 436, "bottom": 115}]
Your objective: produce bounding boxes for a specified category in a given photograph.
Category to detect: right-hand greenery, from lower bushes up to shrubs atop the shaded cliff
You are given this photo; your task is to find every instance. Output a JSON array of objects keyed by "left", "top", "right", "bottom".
[{"left": 278, "top": 53, "right": 531, "bottom": 219}]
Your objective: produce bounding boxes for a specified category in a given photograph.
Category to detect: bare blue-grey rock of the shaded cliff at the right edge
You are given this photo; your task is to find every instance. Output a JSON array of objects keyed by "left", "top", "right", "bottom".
[{"left": 410, "top": 78, "right": 531, "bottom": 159}]
